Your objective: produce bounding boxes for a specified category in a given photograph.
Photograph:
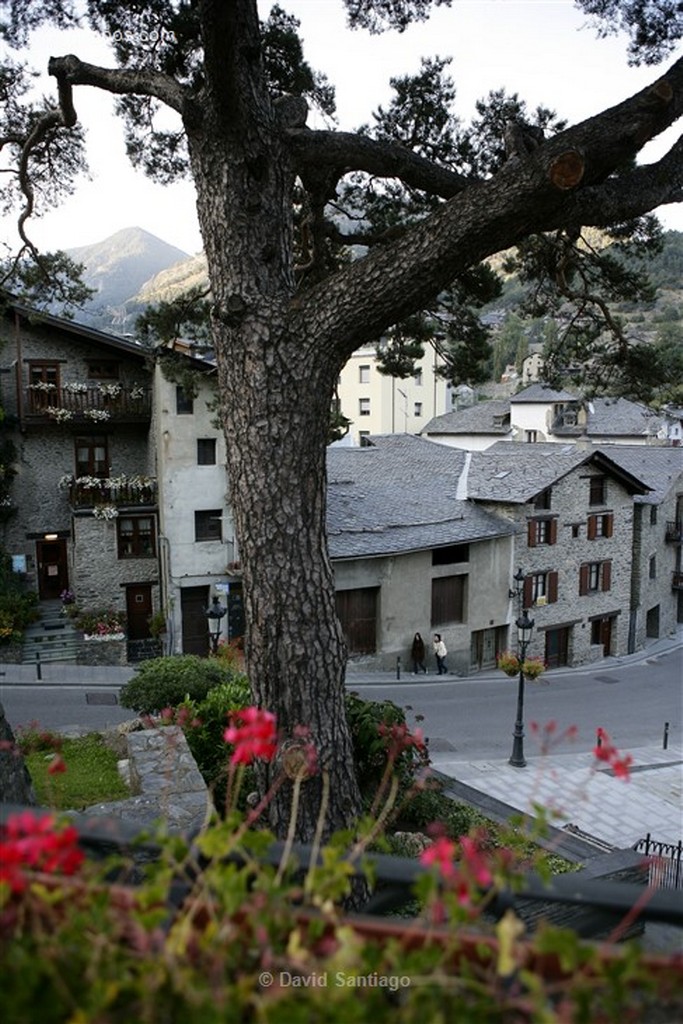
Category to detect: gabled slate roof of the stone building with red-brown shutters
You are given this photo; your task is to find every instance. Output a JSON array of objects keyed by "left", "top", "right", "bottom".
[{"left": 468, "top": 441, "right": 647, "bottom": 504}]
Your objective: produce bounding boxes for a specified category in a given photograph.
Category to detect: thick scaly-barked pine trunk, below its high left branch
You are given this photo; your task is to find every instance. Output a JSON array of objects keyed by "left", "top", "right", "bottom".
[{"left": 184, "top": 83, "right": 359, "bottom": 840}]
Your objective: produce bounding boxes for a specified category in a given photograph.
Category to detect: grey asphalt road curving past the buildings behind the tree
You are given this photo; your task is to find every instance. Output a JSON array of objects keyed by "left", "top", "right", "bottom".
[{"left": 0, "top": 647, "right": 683, "bottom": 760}]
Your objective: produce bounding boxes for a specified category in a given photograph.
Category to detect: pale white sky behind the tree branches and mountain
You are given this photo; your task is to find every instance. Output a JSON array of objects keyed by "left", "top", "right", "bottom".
[{"left": 1, "top": 0, "right": 683, "bottom": 253}]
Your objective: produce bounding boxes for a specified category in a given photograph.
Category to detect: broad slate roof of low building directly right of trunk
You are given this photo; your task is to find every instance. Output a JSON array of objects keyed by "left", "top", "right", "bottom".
[{"left": 328, "top": 434, "right": 515, "bottom": 559}]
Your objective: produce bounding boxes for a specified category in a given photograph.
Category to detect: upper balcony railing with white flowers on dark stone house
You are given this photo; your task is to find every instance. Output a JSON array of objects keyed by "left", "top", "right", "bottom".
[{"left": 24, "top": 384, "right": 152, "bottom": 424}]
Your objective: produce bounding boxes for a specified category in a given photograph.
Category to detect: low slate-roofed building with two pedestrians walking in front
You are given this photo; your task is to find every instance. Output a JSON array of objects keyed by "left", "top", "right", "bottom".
[{"left": 328, "top": 435, "right": 515, "bottom": 675}]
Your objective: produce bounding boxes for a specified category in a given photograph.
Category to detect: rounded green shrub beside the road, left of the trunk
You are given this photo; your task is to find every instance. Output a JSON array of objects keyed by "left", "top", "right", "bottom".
[{"left": 119, "top": 654, "right": 248, "bottom": 715}]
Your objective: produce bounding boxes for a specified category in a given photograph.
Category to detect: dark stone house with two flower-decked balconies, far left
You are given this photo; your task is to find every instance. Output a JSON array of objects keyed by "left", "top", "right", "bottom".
[{"left": 0, "top": 305, "right": 159, "bottom": 640}]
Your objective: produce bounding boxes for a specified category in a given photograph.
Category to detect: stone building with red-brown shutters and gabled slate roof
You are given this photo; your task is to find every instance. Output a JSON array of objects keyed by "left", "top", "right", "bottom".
[{"left": 467, "top": 442, "right": 648, "bottom": 668}]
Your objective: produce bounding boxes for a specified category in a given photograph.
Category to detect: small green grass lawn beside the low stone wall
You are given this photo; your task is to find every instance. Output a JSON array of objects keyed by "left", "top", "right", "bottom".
[{"left": 26, "top": 732, "right": 130, "bottom": 811}]
